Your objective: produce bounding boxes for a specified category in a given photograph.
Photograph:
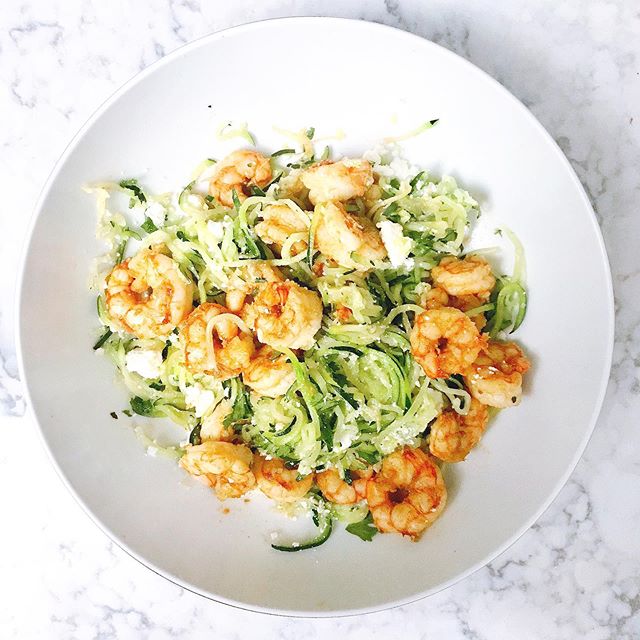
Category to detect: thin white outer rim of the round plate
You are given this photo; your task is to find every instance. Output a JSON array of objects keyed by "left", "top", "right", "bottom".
[{"left": 14, "top": 16, "right": 615, "bottom": 619}]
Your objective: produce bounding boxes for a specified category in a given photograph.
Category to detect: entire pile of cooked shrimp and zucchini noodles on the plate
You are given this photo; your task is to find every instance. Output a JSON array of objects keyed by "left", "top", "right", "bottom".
[{"left": 94, "top": 141, "right": 530, "bottom": 551}]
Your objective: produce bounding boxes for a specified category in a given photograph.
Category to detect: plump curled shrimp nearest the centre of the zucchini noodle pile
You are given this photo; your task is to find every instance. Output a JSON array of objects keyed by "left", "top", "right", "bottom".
[{"left": 248, "top": 280, "right": 322, "bottom": 349}]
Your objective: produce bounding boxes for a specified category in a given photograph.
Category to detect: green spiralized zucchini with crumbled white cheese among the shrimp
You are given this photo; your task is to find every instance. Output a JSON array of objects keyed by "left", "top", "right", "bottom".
[{"left": 90, "top": 138, "right": 526, "bottom": 512}]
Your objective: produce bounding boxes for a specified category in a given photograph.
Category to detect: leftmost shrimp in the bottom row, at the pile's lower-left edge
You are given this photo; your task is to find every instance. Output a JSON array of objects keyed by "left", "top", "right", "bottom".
[{"left": 180, "top": 440, "right": 256, "bottom": 500}]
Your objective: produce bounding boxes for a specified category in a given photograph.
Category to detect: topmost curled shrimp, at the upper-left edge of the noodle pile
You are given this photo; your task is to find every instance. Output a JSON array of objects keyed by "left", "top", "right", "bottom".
[{"left": 209, "top": 149, "right": 271, "bottom": 207}]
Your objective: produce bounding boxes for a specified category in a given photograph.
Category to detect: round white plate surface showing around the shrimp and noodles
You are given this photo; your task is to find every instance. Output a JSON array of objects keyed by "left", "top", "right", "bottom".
[{"left": 18, "top": 18, "right": 613, "bottom": 615}]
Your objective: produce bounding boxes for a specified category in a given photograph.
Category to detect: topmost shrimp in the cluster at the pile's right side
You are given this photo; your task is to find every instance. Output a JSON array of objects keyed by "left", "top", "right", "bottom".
[{"left": 431, "top": 256, "right": 496, "bottom": 300}]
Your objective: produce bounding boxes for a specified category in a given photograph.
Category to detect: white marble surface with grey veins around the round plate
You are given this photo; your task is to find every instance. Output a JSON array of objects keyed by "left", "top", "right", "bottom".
[{"left": 0, "top": 0, "right": 640, "bottom": 640}]
